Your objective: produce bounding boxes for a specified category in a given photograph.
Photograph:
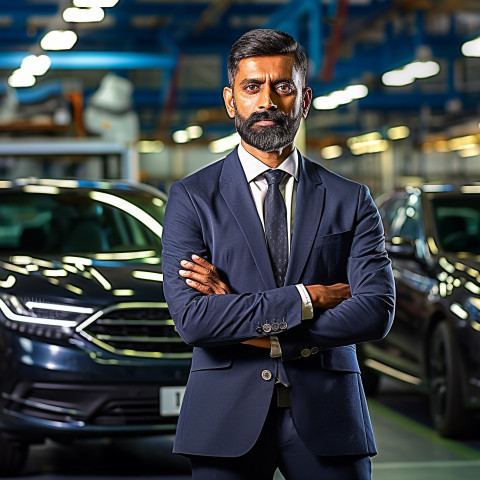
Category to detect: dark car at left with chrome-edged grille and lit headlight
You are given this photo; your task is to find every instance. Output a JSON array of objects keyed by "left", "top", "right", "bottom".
[{"left": 0, "top": 179, "right": 192, "bottom": 475}]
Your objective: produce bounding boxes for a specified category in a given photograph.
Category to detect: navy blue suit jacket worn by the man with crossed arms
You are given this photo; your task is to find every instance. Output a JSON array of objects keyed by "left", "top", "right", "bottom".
[{"left": 163, "top": 150, "right": 394, "bottom": 457}]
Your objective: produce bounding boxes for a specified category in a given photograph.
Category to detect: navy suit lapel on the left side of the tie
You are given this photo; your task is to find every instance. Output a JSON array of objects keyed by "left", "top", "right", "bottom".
[{"left": 220, "top": 149, "right": 275, "bottom": 289}]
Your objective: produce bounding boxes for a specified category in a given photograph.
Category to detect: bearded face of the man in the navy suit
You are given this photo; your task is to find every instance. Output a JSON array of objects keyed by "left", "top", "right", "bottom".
[{"left": 224, "top": 55, "right": 311, "bottom": 152}]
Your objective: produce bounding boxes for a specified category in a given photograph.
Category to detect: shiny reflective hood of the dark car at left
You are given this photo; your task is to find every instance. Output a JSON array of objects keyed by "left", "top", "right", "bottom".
[{"left": 0, "top": 257, "right": 165, "bottom": 306}]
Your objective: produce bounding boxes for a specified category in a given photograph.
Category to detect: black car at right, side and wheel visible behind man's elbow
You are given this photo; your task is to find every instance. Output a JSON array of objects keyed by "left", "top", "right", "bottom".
[{"left": 359, "top": 184, "right": 480, "bottom": 436}]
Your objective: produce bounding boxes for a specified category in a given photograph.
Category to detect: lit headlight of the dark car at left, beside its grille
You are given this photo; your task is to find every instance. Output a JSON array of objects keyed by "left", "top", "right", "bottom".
[{"left": 0, "top": 293, "right": 94, "bottom": 338}]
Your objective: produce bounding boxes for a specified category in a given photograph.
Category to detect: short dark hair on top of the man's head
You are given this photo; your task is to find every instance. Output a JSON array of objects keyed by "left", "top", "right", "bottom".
[{"left": 228, "top": 28, "right": 308, "bottom": 88}]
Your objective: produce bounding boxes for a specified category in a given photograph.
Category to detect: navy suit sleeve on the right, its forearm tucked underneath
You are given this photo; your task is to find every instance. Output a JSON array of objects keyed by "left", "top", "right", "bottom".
[{"left": 279, "top": 186, "right": 395, "bottom": 361}]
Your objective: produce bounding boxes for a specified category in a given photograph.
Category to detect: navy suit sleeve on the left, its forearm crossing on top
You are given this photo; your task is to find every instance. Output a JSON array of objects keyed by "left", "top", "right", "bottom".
[{"left": 162, "top": 182, "right": 302, "bottom": 347}]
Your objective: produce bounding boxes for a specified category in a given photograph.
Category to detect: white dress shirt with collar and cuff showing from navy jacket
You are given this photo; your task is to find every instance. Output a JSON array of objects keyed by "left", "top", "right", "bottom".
[{"left": 238, "top": 144, "right": 313, "bottom": 357}]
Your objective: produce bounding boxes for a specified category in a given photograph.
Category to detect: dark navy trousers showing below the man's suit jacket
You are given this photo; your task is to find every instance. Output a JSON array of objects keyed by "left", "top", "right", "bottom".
[{"left": 189, "top": 396, "right": 371, "bottom": 480}]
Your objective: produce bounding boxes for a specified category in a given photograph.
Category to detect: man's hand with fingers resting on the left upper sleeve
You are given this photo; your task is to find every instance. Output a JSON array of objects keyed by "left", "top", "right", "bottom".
[{"left": 178, "top": 255, "right": 230, "bottom": 295}]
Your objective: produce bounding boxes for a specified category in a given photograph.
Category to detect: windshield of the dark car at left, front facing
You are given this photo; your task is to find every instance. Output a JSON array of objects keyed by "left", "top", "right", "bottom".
[{"left": 0, "top": 186, "right": 165, "bottom": 260}]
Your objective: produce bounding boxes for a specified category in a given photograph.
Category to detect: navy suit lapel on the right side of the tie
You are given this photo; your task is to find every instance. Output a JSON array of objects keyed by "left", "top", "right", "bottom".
[{"left": 285, "top": 155, "right": 325, "bottom": 285}]
